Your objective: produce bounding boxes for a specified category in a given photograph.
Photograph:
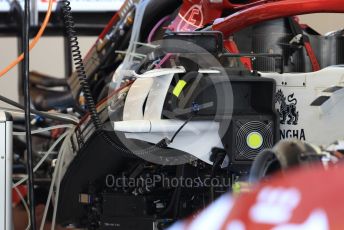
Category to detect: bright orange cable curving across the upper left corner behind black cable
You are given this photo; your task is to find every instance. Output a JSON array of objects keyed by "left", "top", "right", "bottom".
[{"left": 0, "top": 0, "right": 53, "bottom": 77}]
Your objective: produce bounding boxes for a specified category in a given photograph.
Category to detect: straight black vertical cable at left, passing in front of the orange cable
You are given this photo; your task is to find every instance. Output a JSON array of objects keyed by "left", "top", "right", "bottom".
[{"left": 22, "top": 0, "right": 36, "bottom": 230}]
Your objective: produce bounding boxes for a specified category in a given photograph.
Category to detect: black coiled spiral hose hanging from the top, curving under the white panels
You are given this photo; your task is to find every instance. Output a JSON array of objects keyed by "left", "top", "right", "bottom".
[{"left": 61, "top": 0, "right": 169, "bottom": 156}]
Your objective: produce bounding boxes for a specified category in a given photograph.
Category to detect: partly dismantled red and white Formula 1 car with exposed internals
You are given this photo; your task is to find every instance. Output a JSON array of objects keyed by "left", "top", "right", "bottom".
[{"left": 2, "top": 0, "right": 344, "bottom": 230}]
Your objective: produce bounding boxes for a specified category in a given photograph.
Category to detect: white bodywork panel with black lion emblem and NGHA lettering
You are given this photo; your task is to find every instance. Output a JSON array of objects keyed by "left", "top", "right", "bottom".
[{"left": 262, "top": 66, "right": 344, "bottom": 146}]
